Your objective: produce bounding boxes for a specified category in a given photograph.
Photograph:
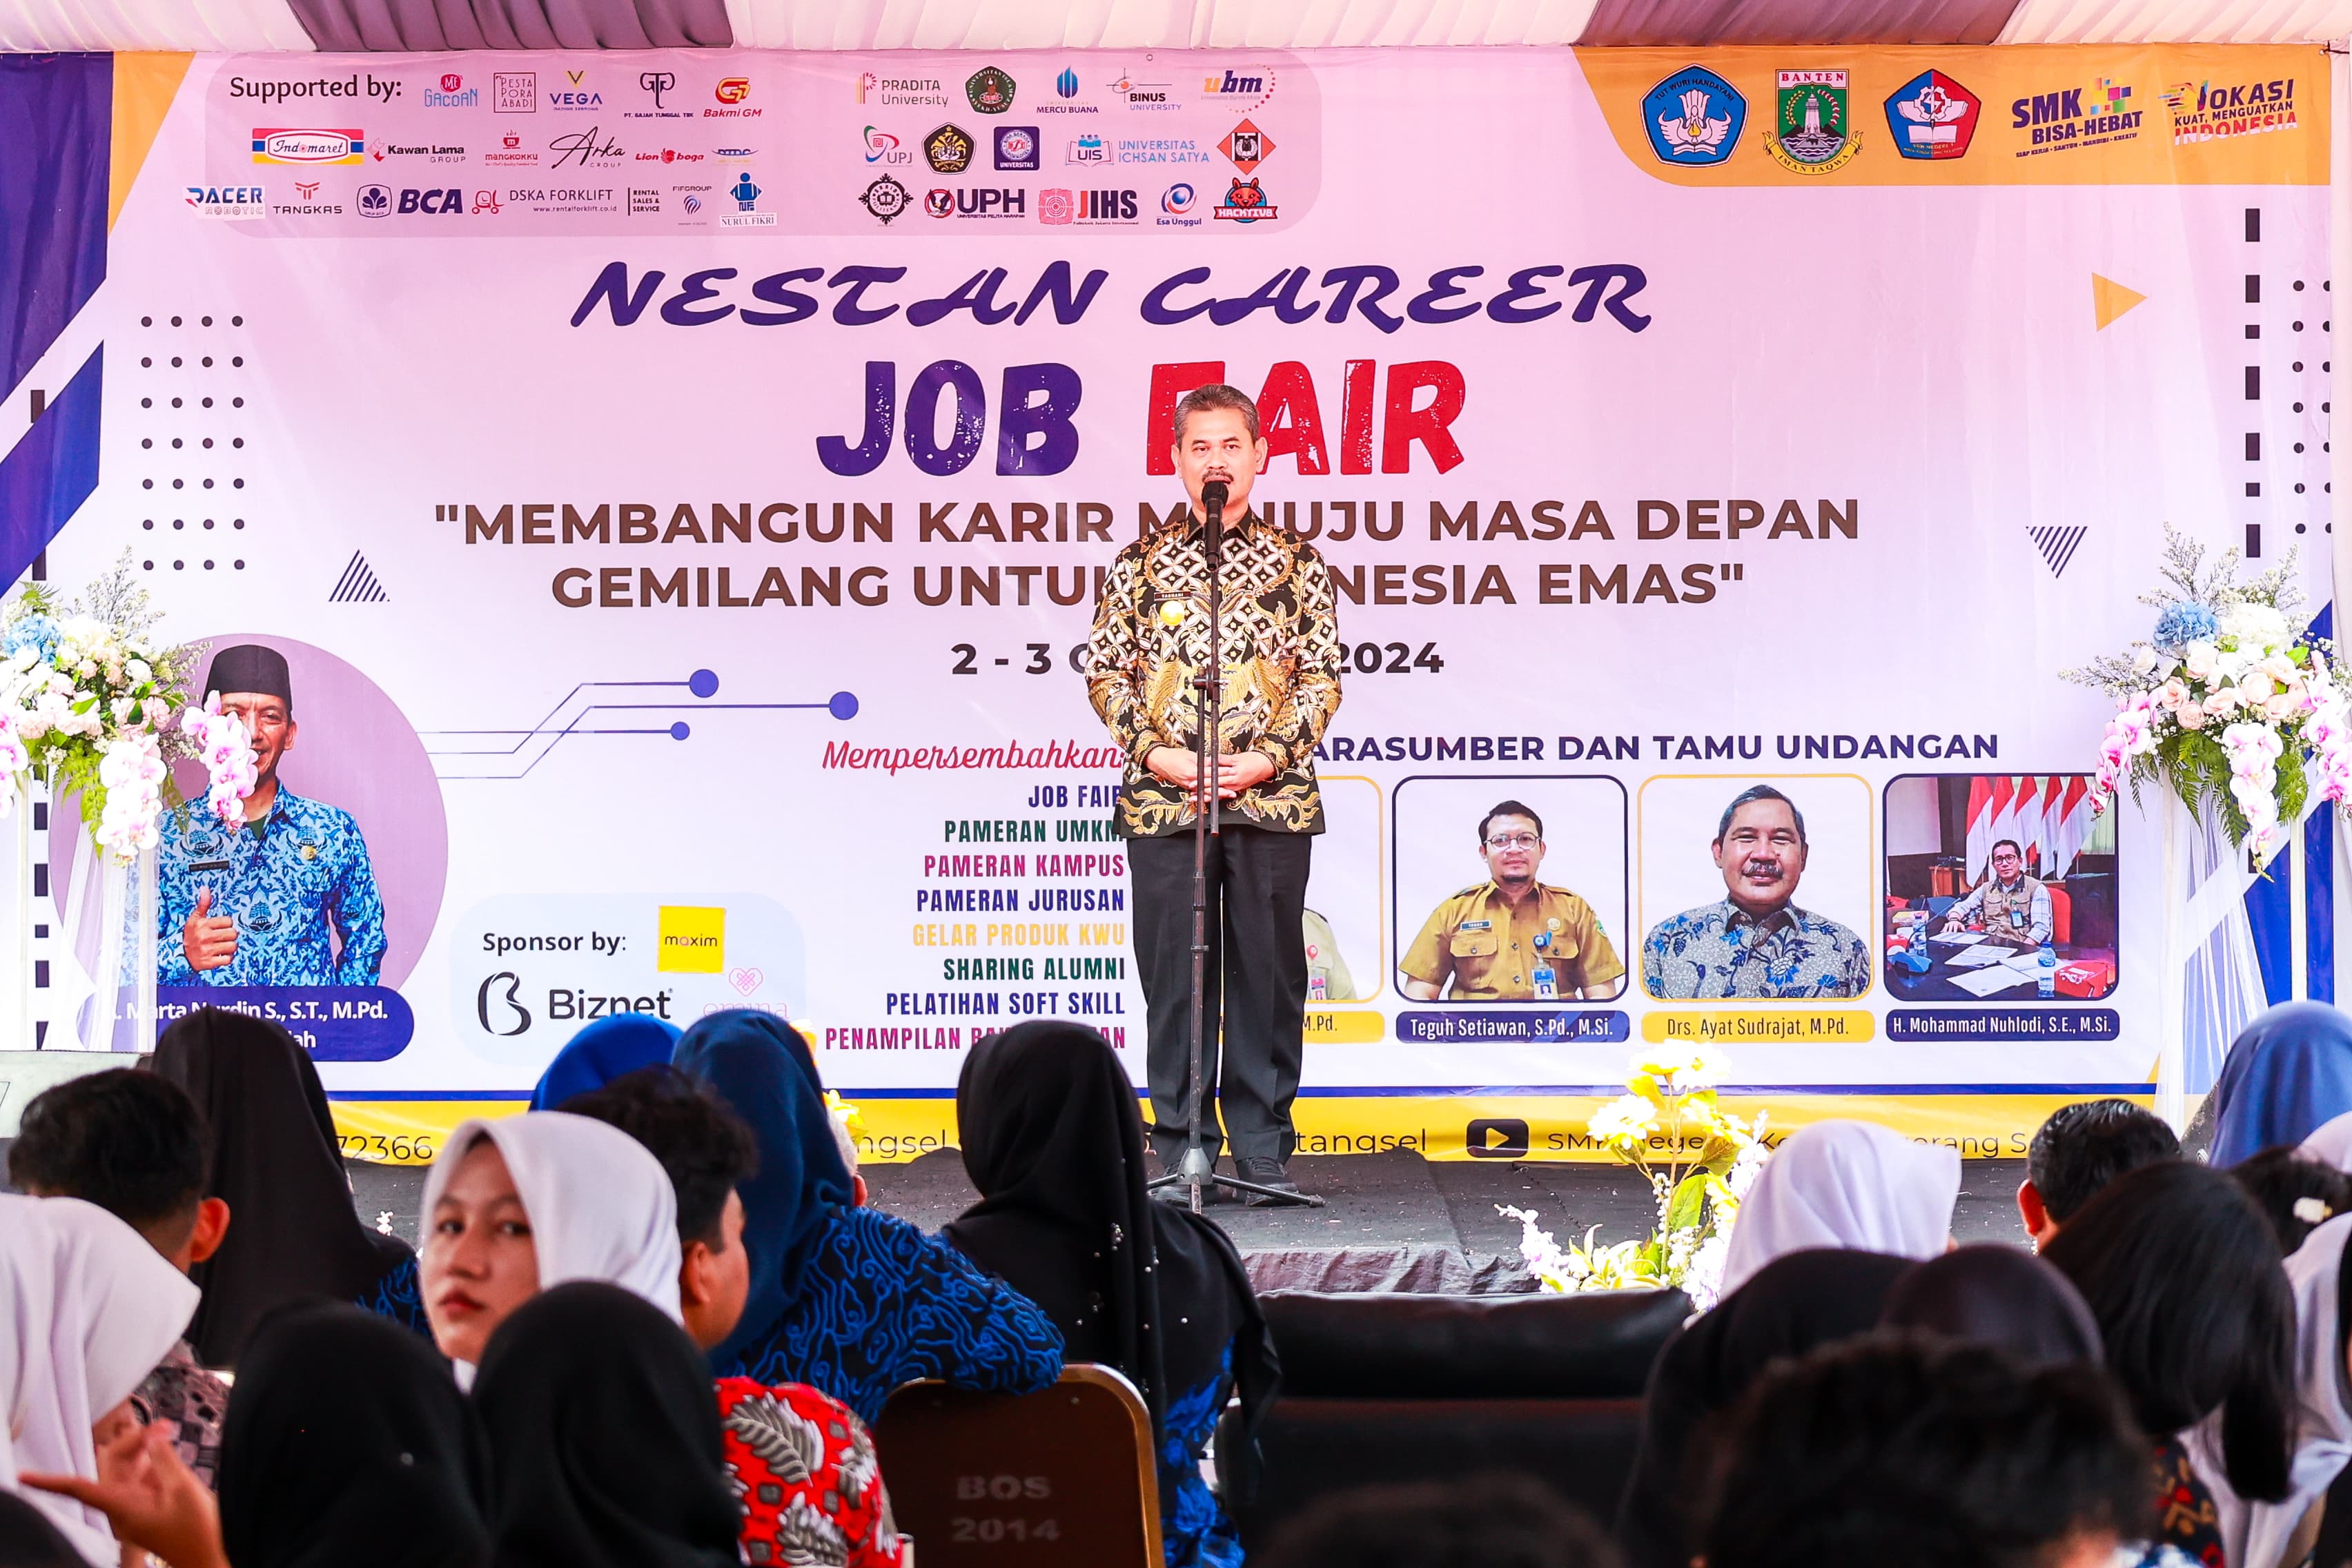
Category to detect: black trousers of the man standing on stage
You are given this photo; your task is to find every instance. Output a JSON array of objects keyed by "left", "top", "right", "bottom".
[{"left": 1126, "top": 823, "right": 1315, "bottom": 1170}]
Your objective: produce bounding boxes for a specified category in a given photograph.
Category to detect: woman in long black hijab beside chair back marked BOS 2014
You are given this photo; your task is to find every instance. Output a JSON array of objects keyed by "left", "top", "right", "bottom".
[{"left": 943, "top": 1020, "right": 1277, "bottom": 1568}]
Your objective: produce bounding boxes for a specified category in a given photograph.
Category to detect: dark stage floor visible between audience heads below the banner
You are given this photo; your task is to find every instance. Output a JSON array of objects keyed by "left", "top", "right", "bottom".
[{"left": 348, "top": 1150, "right": 2025, "bottom": 1257}]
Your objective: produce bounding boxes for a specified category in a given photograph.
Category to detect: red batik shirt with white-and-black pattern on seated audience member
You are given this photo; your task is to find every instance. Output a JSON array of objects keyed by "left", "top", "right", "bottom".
[{"left": 717, "top": 1378, "right": 908, "bottom": 1568}]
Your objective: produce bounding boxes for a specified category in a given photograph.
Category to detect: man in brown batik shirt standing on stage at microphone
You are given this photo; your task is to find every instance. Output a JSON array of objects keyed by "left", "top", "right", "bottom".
[{"left": 1086, "top": 386, "right": 1343, "bottom": 1204}]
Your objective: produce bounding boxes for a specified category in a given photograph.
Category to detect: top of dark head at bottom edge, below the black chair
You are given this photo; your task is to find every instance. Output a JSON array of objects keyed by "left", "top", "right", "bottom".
[{"left": 1251, "top": 1476, "right": 1616, "bottom": 1568}]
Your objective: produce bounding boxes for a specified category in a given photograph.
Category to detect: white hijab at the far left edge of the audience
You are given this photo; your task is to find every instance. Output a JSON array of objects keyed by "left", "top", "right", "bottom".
[{"left": 0, "top": 1194, "right": 200, "bottom": 1563}]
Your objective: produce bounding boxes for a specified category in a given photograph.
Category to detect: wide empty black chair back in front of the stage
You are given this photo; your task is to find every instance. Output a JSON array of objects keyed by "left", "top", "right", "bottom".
[{"left": 1218, "top": 1291, "right": 1691, "bottom": 1551}]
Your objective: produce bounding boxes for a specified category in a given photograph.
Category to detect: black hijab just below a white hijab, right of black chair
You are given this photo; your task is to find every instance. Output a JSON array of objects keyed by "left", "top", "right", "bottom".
[{"left": 1618, "top": 1248, "right": 1914, "bottom": 1568}]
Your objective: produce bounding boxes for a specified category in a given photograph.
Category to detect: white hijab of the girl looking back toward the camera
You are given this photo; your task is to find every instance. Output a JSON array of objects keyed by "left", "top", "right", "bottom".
[{"left": 423, "top": 1110, "right": 685, "bottom": 1384}]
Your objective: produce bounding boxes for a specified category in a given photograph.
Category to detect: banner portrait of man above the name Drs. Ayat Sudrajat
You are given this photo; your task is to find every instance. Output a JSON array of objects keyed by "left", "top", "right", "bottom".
[{"left": 1642, "top": 785, "right": 1870, "bottom": 1001}]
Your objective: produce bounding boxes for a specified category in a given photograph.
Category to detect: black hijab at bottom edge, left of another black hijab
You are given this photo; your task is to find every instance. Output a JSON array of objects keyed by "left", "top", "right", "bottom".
[{"left": 221, "top": 1302, "right": 489, "bottom": 1568}]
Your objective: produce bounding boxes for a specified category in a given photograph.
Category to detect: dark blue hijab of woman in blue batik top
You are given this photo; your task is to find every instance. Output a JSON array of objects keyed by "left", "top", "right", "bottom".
[{"left": 670, "top": 1008, "right": 852, "bottom": 1366}]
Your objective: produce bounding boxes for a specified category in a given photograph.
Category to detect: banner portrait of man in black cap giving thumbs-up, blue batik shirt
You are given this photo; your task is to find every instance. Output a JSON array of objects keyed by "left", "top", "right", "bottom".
[{"left": 155, "top": 642, "right": 384, "bottom": 985}]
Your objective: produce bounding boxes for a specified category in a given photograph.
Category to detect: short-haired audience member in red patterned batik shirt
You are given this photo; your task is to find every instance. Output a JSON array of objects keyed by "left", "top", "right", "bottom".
[{"left": 565, "top": 1065, "right": 905, "bottom": 1568}]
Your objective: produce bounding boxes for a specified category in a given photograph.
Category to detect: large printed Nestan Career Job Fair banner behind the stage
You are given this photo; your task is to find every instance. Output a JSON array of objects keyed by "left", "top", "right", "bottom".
[{"left": 28, "top": 47, "right": 2331, "bottom": 1159}]
